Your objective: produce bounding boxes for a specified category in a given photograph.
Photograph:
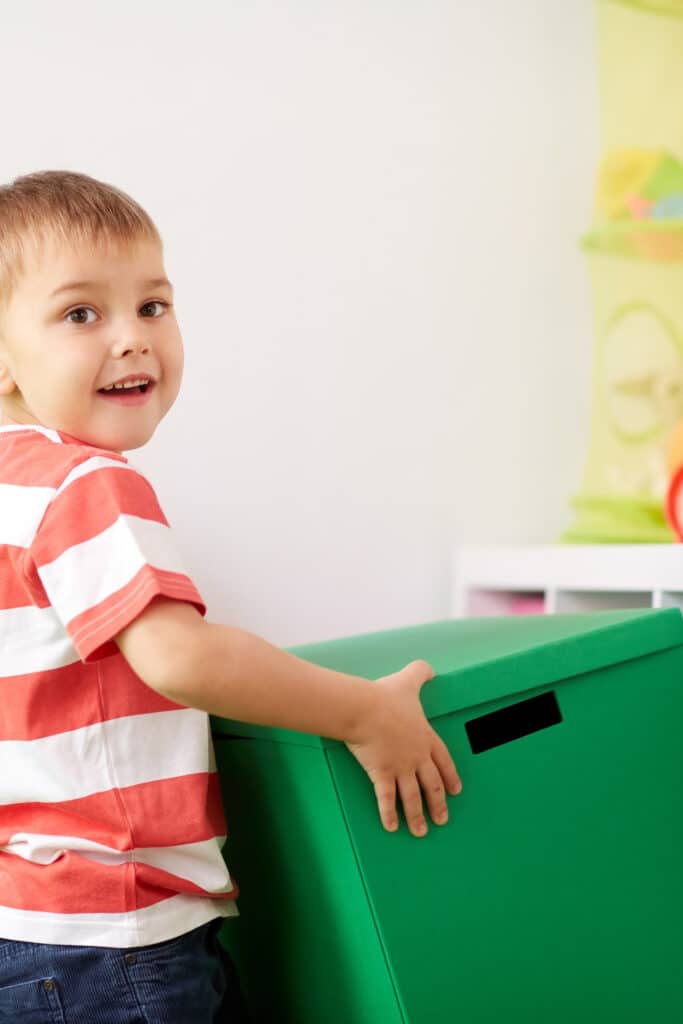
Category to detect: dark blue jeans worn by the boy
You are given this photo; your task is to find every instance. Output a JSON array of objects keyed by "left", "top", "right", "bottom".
[{"left": 0, "top": 918, "right": 248, "bottom": 1024}]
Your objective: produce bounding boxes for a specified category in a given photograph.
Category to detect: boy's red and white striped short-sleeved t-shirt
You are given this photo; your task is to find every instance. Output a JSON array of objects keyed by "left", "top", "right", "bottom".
[{"left": 0, "top": 426, "right": 237, "bottom": 947}]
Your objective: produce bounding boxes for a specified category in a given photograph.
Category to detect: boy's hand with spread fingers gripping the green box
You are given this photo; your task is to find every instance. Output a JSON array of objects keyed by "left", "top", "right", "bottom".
[{"left": 347, "top": 662, "right": 462, "bottom": 836}]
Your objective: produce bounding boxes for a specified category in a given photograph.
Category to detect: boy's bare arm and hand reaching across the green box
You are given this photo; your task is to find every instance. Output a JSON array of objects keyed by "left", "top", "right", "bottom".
[{"left": 115, "top": 597, "right": 461, "bottom": 836}]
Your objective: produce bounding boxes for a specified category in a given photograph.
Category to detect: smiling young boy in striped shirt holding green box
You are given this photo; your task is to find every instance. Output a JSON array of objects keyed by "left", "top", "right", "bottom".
[{"left": 0, "top": 171, "right": 461, "bottom": 1024}]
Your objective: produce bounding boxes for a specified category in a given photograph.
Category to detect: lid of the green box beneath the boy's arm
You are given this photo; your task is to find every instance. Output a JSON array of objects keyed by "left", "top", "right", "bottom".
[{"left": 212, "top": 608, "right": 683, "bottom": 746}]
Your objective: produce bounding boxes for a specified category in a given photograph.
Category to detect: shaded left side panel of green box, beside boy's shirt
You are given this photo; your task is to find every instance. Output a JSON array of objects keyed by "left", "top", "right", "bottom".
[{"left": 215, "top": 739, "right": 402, "bottom": 1024}]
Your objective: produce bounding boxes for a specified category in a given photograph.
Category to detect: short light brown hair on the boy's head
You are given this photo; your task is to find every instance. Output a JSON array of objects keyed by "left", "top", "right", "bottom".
[{"left": 0, "top": 171, "right": 161, "bottom": 308}]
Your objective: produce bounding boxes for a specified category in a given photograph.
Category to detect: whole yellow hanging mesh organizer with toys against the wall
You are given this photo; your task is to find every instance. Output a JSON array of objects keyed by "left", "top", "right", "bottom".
[{"left": 561, "top": 0, "right": 683, "bottom": 544}]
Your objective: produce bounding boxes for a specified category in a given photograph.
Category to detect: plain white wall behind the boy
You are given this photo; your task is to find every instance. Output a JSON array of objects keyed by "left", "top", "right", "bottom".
[{"left": 0, "top": 0, "right": 597, "bottom": 644}]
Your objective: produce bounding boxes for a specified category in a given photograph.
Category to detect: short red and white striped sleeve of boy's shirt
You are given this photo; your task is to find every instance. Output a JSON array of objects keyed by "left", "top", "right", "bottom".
[{"left": 30, "top": 457, "right": 206, "bottom": 663}]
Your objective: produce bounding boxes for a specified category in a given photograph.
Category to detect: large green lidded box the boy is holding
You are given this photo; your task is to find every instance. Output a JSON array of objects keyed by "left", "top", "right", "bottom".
[{"left": 213, "top": 609, "right": 683, "bottom": 1024}]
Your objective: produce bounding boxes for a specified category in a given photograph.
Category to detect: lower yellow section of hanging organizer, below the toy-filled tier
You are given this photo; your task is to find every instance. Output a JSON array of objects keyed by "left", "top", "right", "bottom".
[{"left": 562, "top": 250, "right": 683, "bottom": 544}]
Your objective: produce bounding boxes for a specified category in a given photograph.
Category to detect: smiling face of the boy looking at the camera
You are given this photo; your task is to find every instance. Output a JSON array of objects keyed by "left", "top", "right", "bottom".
[{"left": 0, "top": 240, "right": 183, "bottom": 452}]
